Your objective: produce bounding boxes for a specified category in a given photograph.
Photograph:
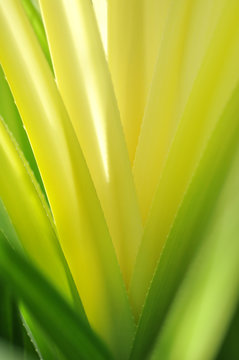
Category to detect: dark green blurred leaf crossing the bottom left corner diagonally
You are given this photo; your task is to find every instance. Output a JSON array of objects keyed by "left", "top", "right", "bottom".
[{"left": 0, "top": 234, "right": 111, "bottom": 360}]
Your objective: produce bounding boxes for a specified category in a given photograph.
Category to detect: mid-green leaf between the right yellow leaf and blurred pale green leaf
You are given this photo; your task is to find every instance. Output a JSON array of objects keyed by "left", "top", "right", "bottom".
[{"left": 132, "top": 79, "right": 239, "bottom": 360}]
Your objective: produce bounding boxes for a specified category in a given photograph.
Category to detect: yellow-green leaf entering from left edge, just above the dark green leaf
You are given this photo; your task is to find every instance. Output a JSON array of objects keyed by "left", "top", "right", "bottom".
[{"left": 0, "top": 116, "right": 79, "bottom": 308}]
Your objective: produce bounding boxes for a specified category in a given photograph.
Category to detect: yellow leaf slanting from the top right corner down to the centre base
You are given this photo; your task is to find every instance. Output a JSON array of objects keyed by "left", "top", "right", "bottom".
[{"left": 131, "top": 1, "right": 239, "bottom": 311}]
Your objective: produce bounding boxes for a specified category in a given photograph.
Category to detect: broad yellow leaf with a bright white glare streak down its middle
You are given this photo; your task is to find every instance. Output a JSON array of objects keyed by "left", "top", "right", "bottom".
[{"left": 37, "top": 0, "right": 142, "bottom": 284}]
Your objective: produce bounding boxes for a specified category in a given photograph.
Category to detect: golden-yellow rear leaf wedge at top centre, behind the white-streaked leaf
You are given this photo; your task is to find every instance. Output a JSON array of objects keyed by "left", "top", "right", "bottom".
[{"left": 107, "top": 0, "right": 171, "bottom": 163}]
